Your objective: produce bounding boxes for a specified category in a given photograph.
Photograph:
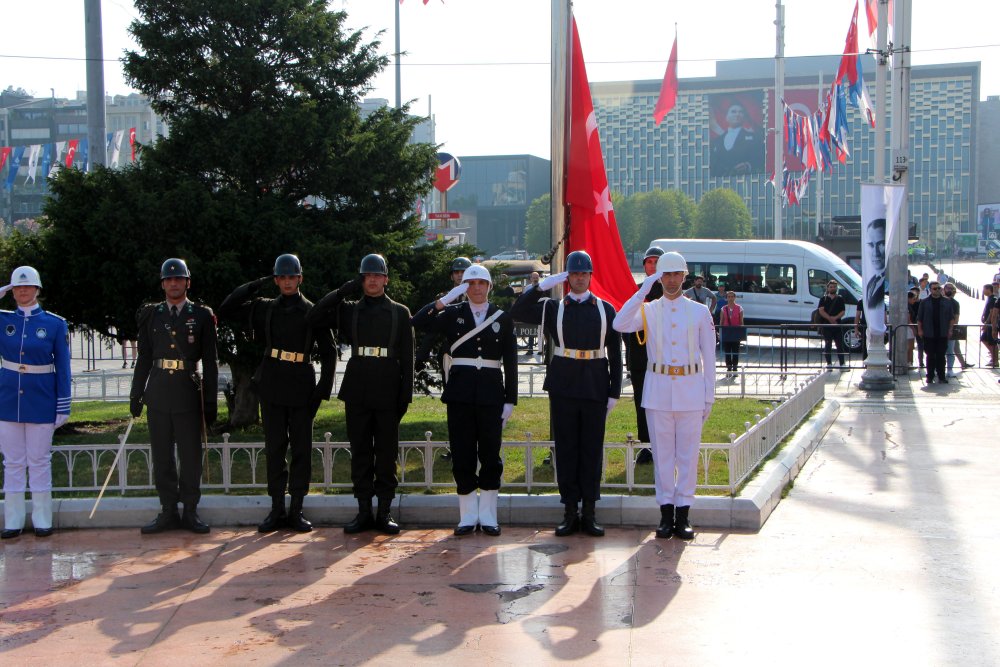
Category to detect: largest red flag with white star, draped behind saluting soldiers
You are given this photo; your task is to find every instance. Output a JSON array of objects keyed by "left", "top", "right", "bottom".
[{"left": 566, "top": 19, "right": 635, "bottom": 310}]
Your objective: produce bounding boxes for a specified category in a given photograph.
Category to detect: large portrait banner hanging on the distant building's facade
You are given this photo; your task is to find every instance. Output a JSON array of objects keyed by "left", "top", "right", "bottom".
[{"left": 708, "top": 90, "right": 767, "bottom": 176}]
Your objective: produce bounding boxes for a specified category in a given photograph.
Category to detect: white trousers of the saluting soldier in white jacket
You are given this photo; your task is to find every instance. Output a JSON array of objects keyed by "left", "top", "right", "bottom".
[{"left": 646, "top": 408, "right": 704, "bottom": 507}]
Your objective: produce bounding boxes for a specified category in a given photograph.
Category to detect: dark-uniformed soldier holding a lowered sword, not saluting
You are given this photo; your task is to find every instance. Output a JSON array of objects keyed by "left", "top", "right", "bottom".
[{"left": 129, "top": 259, "right": 219, "bottom": 535}]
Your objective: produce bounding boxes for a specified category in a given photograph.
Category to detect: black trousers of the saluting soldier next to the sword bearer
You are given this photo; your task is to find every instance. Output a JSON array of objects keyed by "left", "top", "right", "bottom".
[{"left": 260, "top": 401, "right": 313, "bottom": 499}]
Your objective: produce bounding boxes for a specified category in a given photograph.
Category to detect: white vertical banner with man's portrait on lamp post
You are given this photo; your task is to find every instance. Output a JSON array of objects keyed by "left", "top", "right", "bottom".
[{"left": 861, "top": 183, "right": 906, "bottom": 336}]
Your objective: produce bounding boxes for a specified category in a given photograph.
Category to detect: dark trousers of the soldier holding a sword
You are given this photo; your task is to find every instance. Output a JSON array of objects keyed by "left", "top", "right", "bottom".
[{"left": 146, "top": 406, "right": 202, "bottom": 507}]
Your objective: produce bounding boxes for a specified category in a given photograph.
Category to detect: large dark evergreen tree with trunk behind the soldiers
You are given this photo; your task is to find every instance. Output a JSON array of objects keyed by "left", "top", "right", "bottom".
[{"left": 24, "top": 0, "right": 451, "bottom": 425}]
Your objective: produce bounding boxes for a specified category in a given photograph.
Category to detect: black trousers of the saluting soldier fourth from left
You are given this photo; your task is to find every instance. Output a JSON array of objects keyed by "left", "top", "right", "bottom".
[{"left": 344, "top": 403, "right": 399, "bottom": 501}]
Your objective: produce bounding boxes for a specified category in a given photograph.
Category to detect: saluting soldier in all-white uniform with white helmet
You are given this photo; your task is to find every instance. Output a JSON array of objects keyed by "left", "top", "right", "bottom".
[{"left": 614, "top": 252, "right": 715, "bottom": 540}]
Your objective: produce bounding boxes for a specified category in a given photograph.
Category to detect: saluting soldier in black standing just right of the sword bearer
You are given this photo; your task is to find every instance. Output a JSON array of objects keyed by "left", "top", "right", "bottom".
[{"left": 219, "top": 254, "right": 337, "bottom": 533}]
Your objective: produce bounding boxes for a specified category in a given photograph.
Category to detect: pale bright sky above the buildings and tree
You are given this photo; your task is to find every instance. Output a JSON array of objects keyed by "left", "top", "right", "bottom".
[{"left": 0, "top": 0, "right": 1000, "bottom": 158}]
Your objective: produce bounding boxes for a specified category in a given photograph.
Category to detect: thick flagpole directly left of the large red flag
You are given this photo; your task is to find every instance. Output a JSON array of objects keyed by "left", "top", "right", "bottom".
[{"left": 549, "top": 0, "right": 571, "bottom": 273}]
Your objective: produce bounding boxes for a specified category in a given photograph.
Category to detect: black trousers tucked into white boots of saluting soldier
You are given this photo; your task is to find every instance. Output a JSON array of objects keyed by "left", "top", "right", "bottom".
[{"left": 448, "top": 403, "right": 503, "bottom": 496}]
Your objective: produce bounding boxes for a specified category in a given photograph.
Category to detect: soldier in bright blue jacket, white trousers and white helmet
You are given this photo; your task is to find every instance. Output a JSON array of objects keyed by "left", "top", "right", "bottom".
[{"left": 0, "top": 266, "right": 71, "bottom": 540}]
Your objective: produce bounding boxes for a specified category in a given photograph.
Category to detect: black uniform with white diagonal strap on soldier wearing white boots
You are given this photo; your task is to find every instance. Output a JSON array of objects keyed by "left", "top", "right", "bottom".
[{"left": 413, "top": 301, "right": 517, "bottom": 529}]
